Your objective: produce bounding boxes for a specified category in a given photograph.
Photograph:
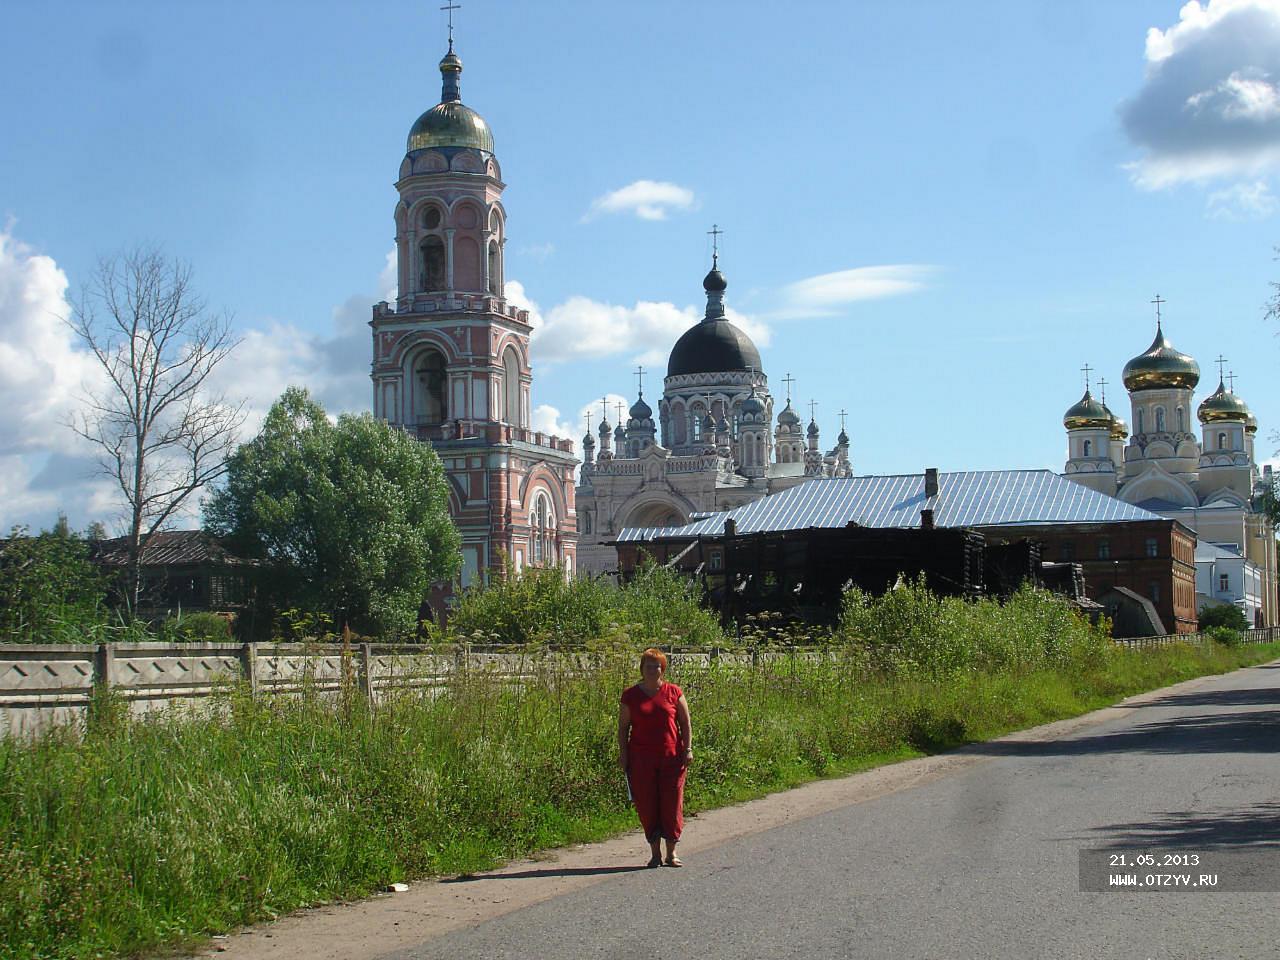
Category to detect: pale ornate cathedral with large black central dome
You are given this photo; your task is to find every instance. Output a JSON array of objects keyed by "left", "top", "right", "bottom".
[{"left": 576, "top": 257, "right": 852, "bottom": 573}]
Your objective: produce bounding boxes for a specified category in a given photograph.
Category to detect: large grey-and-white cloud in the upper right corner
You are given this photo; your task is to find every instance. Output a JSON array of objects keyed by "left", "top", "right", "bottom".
[{"left": 1120, "top": 0, "right": 1280, "bottom": 189}]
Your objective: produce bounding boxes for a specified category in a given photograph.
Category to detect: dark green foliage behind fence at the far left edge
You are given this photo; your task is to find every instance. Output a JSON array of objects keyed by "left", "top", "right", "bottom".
[{"left": 0, "top": 521, "right": 109, "bottom": 644}]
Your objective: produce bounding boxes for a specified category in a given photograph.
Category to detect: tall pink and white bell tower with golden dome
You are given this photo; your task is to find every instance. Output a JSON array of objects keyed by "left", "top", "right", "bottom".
[{"left": 370, "top": 42, "right": 579, "bottom": 586}]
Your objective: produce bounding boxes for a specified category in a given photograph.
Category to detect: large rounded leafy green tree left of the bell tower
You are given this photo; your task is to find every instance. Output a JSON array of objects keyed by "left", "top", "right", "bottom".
[{"left": 204, "top": 387, "right": 461, "bottom": 635}]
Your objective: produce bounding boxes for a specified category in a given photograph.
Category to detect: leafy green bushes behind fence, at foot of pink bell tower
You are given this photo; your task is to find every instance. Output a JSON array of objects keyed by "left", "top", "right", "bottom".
[{"left": 449, "top": 564, "right": 724, "bottom": 646}]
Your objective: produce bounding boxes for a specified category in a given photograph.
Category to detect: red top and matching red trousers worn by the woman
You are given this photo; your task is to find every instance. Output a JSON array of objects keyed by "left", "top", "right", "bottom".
[{"left": 622, "top": 684, "right": 687, "bottom": 844}]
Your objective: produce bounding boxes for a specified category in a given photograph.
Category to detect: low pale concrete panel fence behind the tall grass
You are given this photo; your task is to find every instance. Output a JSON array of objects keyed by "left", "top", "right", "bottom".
[{"left": 0, "top": 627, "right": 1280, "bottom": 736}]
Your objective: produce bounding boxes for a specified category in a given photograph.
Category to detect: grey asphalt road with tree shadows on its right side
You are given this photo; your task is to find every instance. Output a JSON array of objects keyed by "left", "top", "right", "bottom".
[{"left": 381, "top": 663, "right": 1280, "bottom": 960}]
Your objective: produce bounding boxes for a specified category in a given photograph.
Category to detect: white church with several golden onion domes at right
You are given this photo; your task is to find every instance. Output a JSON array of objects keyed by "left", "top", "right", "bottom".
[{"left": 1062, "top": 312, "right": 1277, "bottom": 626}]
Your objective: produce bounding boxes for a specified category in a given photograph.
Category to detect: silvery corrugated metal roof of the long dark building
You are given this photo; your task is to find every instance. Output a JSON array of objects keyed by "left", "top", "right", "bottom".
[{"left": 618, "top": 470, "right": 1162, "bottom": 543}]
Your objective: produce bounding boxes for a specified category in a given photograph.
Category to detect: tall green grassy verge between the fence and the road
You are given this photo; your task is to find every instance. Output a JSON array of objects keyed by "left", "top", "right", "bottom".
[{"left": 0, "top": 645, "right": 1280, "bottom": 960}]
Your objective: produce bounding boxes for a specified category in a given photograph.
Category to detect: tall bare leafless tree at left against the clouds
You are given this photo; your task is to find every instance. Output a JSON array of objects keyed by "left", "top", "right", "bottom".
[{"left": 67, "top": 250, "right": 244, "bottom": 611}]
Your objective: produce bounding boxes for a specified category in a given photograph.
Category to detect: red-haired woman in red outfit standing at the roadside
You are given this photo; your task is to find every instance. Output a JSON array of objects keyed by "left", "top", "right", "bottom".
[{"left": 618, "top": 646, "right": 694, "bottom": 867}]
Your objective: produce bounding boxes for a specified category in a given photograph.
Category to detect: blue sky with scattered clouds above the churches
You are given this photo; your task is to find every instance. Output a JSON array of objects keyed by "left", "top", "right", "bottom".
[{"left": 0, "top": 0, "right": 1280, "bottom": 530}]
